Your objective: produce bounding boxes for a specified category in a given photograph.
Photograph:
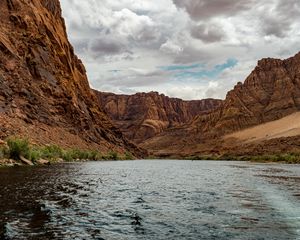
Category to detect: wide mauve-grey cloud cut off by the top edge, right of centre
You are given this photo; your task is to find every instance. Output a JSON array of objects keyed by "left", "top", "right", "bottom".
[{"left": 173, "top": 0, "right": 254, "bottom": 20}]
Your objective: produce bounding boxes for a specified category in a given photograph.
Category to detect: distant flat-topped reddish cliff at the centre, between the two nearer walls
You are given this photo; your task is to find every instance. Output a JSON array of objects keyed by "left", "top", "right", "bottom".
[{"left": 95, "top": 91, "right": 221, "bottom": 143}]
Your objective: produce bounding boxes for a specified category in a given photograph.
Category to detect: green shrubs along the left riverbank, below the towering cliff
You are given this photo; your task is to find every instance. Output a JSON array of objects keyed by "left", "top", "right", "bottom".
[{"left": 0, "top": 138, "right": 133, "bottom": 165}]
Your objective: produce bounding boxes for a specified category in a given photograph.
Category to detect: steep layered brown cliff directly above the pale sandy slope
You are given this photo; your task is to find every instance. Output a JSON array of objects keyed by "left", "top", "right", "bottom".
[{"left": 194, "top": 53, "right": 300, "bottom": 135}]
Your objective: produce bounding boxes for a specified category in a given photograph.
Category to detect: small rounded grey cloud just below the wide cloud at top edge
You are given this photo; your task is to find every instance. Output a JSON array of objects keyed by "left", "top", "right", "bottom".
[{"left": 191, "top": 24, "right": 225, "bottom": 43}]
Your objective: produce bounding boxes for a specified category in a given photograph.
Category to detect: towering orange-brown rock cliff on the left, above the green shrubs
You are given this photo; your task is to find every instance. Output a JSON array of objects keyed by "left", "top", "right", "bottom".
[{"left": 0, "top": 0, "right": 142, "bottom": 156}]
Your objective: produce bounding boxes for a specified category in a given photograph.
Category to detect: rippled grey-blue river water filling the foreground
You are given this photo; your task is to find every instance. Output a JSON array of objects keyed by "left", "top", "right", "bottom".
[{"left": 0, "top": 160, "right": 300, "bottom": 240}]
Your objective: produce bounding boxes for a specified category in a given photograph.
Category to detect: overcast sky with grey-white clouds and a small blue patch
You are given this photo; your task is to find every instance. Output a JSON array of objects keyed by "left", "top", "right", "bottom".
[{"left": 61, "top": 0, "right": 300, "bottom": 99}]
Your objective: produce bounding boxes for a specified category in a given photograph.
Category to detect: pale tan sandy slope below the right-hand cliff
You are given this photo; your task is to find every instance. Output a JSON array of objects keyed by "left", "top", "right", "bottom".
[{"left": 224, "top": 112, "right": 300, "bottom": 142}]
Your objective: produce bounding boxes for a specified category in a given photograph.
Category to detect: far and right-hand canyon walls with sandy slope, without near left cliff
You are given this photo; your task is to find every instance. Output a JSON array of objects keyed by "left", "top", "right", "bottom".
[{"left": 95, "top": 53, "right": 300, "bottom": 158}]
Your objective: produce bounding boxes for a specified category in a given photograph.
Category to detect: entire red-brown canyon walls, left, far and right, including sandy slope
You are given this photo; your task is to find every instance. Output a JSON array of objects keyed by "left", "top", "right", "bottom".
[{"left": 0, "top": 0, "right": 300, "bottom": 161}]
